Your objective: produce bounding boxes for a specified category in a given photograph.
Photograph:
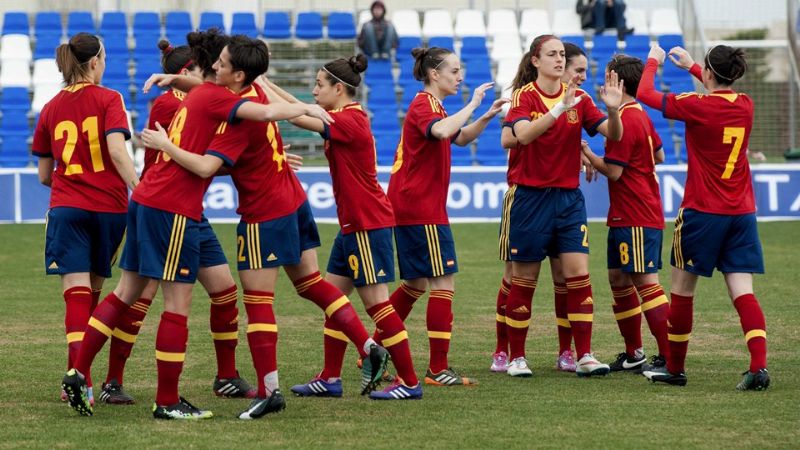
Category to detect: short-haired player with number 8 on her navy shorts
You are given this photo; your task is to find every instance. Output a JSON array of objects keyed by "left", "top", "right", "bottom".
[{"left": 583, "top": 55, "right": 669, "bottom": 373}]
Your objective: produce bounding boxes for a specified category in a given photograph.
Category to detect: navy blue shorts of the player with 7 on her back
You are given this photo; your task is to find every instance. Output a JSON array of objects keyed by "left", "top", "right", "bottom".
[{"left": 670, "top": 208, "right": 764, "bottom": 277}]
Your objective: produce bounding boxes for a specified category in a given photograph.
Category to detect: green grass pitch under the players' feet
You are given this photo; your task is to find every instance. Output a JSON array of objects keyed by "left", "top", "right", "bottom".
[{"left": 0, "top": 222, "right": 800, "bottom": 449}]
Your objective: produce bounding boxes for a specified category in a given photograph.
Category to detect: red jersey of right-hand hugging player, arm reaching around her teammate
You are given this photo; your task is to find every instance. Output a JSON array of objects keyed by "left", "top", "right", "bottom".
[{"left": 209, "top": 85, "right": 306, "bottom": 223}]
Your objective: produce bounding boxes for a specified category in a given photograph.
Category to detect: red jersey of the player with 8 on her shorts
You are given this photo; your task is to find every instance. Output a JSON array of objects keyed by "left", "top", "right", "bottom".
[{"left": 603, "top": 102, "right": 664, "bottom": 229}]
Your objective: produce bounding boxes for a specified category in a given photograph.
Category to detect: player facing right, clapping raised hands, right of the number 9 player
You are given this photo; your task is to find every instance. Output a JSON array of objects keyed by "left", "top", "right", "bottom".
[{"left": 382, "top": 47, "right": 508, "bottom": 386}]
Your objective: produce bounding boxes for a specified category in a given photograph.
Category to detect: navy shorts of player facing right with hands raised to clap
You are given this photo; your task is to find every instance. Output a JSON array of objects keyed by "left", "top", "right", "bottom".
[{"left": 394, "top": 225, "right": 458, "bottom": 280}]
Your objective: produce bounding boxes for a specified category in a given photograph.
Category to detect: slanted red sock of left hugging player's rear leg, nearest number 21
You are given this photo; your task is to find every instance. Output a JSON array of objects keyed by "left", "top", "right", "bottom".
[{"left": 74, "top": 291, "right": 128, "bottom": 382}]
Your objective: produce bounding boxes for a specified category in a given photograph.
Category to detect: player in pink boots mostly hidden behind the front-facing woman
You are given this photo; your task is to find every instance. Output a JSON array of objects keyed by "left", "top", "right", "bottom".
[{"left": 490, "top": 42, "right": 596, "bottom": 372}]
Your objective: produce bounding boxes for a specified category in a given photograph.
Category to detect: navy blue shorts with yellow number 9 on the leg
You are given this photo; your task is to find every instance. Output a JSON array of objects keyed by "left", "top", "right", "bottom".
[{"left": 328, "top": 228, "right": 394, "bottom": 287}]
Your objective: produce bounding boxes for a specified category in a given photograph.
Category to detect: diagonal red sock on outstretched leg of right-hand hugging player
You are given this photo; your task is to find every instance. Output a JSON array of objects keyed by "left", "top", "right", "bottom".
[{"left": 294, "top": 272, "right": 369, "bottom": 358}]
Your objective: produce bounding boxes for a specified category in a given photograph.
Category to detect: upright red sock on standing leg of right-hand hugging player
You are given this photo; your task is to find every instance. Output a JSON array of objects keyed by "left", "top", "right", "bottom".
[{"left": 244, "top": 290, "right": 278, "bottom": 398}]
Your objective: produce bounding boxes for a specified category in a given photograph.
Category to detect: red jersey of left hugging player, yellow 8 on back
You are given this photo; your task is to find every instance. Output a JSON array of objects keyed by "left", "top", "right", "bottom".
[{"left": 131, "top": 82, "right": 247, "bottom": 222}]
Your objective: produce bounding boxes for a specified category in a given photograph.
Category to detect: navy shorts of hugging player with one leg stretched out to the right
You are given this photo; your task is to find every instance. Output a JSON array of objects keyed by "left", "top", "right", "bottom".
[{"left": 236, "top": 200, "right": 320, "bottom": 270}]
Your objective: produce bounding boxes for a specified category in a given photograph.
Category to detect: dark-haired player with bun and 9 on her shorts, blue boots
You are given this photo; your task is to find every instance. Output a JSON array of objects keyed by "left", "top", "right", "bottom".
[{"left": 260, "top": 55, "right": 422, "bottom": 400}]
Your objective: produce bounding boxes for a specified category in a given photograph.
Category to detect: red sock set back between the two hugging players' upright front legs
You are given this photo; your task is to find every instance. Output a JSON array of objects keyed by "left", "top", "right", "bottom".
[{"left": 209, "top": 284, "right": 239, "bottom": 380}]
